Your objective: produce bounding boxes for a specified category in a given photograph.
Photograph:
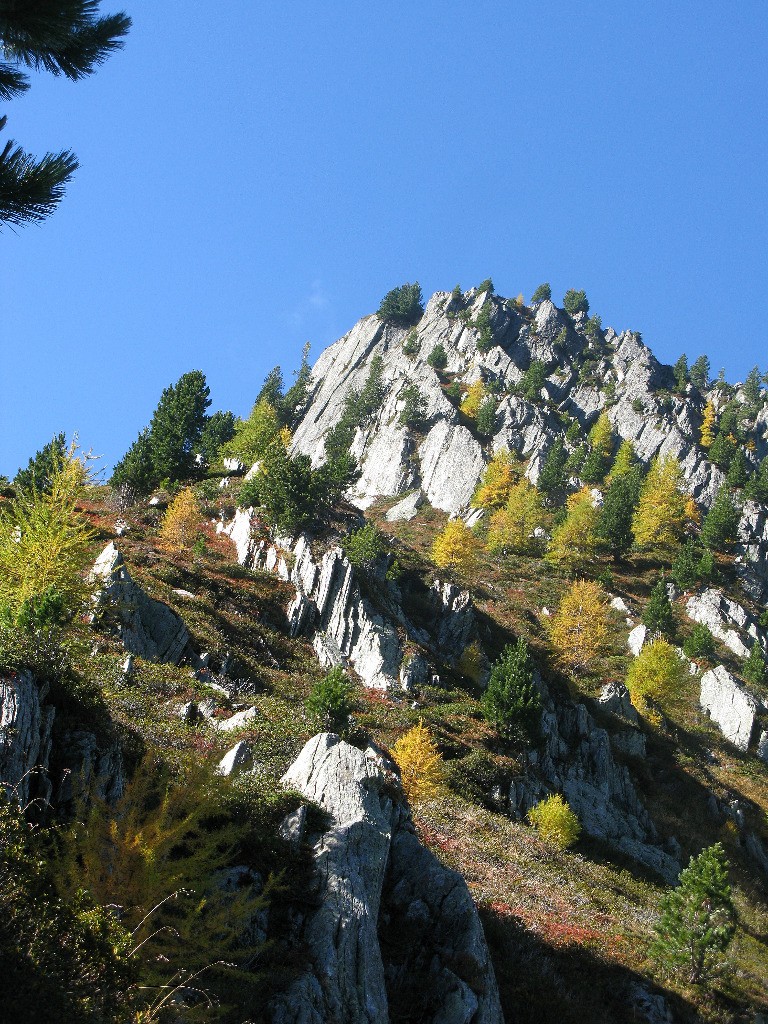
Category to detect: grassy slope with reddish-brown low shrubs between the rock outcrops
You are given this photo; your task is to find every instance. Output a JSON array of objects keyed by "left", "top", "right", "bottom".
[{"left": 79, "top": 481, "right": 768, "bottom": 1024}]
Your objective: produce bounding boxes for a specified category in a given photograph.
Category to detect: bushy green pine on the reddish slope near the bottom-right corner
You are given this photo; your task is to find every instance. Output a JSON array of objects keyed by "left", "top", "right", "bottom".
[{"left": 651, "top": 843, "right": 735, "bottom": 985}]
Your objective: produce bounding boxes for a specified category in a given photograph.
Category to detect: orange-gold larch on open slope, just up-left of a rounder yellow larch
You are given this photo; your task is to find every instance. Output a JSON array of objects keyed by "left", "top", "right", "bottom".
[{"left": 549, "top": 580, "right": 609, "bottom": 672}]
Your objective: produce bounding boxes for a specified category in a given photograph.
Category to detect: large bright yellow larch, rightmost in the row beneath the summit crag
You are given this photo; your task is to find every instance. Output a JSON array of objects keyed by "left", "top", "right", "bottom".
[{"left": 632, "top": 456, "right": 688, "bottom": 554}]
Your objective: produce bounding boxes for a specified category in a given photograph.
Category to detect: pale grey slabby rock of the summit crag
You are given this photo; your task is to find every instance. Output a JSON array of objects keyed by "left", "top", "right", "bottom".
[{"left": 294, "top": 291, "right": 729, "bottom": 512}]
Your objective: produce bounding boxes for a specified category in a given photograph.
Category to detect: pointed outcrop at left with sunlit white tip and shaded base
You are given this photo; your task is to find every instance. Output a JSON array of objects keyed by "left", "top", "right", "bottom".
[{"left": 92, "top": 543, "right": 191, "bottom": 665}]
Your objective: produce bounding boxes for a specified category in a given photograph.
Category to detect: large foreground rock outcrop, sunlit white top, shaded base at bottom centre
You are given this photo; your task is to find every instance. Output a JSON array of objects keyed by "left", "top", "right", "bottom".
[{"left": 270, "top": 733, "right": 503, "bottom": 1024}]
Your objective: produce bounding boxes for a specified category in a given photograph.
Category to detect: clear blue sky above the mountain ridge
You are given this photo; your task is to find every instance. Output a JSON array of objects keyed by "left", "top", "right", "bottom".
[{"left": 0, "top": 0, "right": 768, "bottom": 476}]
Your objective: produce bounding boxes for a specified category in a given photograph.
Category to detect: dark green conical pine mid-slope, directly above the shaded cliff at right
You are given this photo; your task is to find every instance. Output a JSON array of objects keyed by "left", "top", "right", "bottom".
[{"left": 482, "top": 637, "right": 542, "bottom": 739}]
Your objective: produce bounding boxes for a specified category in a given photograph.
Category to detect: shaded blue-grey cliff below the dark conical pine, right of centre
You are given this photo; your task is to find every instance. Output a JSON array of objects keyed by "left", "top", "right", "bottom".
[{"left": 520, "top": 680, "right": 680, "bottom": 882}]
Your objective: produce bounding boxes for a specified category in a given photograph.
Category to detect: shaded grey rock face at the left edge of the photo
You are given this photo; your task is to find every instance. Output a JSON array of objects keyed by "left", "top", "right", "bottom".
[{"left": 0, "top": 672, "right": 55, "bottom": 807}]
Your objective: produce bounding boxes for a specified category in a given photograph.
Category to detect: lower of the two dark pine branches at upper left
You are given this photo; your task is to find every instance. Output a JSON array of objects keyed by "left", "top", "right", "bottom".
[{"left": 0, "top": 141, "right": 78, "bottom": 224}]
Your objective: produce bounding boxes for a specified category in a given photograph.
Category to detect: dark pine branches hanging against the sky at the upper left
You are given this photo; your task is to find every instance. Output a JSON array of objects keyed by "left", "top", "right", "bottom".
[{"left": 0, "top": 0, "right": 131, "bottom": 225}]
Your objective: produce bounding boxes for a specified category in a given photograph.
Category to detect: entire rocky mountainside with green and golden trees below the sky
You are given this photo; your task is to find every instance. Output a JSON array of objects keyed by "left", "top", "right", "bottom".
[{"left": 0, "top": 282, "right": 768, "bottom": 1024}]
